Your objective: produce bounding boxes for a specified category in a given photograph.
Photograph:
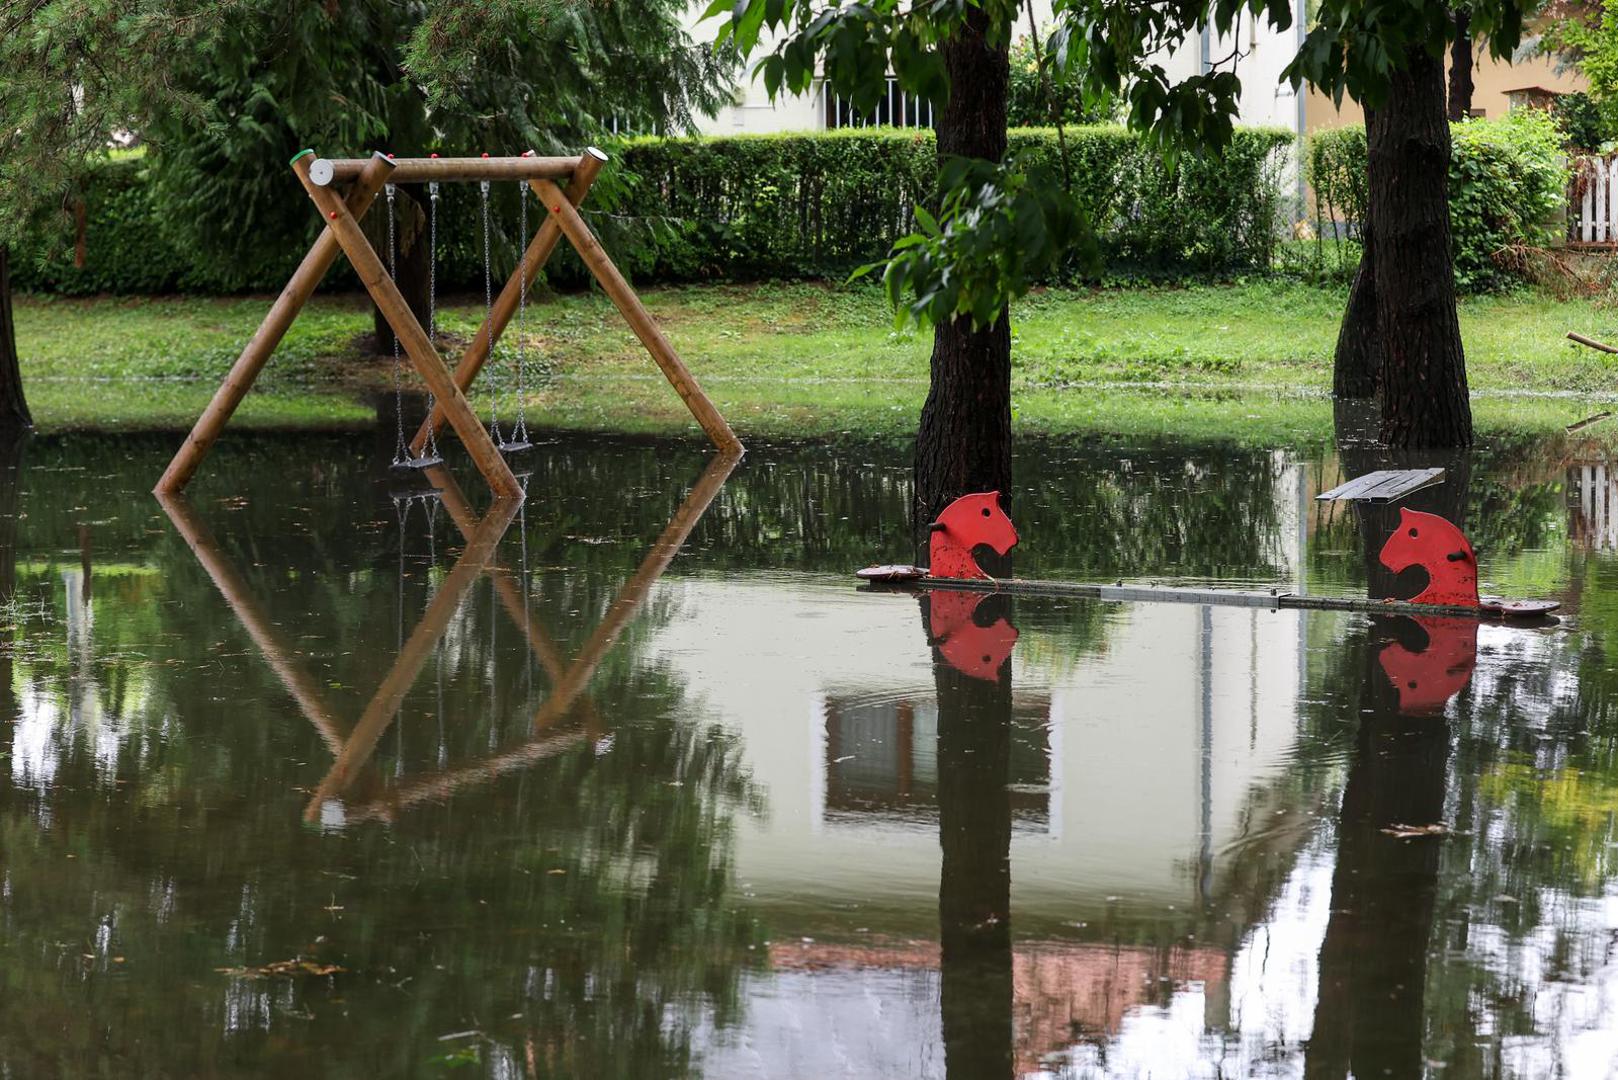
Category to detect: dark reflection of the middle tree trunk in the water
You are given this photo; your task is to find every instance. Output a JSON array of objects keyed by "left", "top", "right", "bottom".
[{"left": 922, "top": 604, "right": 1016, "bottom": 1080}]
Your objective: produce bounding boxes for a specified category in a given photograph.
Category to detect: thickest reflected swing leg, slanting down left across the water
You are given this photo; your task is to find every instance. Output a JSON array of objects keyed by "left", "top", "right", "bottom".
[{"left": 304, "top": 499, "right": 521, "bottom": 821}]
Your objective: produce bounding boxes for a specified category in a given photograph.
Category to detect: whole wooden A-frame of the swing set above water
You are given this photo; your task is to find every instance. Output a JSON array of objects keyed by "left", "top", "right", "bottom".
[{"left": 154, "top": 146, "right": 743, "bottom": 499}]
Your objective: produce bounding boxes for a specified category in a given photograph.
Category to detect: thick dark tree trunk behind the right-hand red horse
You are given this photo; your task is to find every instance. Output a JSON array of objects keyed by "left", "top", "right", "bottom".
[{"left": 1367, "top": 49, "right": 1472, "bottom": 447}]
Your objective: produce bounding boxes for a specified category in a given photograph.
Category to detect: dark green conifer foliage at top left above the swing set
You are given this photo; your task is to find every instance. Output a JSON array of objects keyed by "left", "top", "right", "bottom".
[{"left": 0, "top": 0, "right": 735, "bottom": 291}]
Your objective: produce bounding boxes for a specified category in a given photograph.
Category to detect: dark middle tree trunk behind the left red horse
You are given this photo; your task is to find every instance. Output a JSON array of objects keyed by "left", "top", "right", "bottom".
[{"left": 913, "top": 8, "right": 1011, "bottom": 544}]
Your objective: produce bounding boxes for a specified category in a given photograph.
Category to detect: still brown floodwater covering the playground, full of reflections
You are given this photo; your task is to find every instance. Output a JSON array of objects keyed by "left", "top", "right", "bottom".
[{"left": 0, "top": 436, "right": 1618, "bottom": 1080}]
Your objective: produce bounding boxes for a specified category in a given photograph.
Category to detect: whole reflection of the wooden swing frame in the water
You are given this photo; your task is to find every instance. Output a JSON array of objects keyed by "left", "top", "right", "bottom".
[{"left": 159, "top": 453, "right": 739, "bottom": 823}]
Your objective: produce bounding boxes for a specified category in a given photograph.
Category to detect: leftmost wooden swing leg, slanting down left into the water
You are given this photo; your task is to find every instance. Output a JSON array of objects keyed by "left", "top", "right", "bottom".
[{"left": 152, "top": 151, "right": 393, "bottom": 494}]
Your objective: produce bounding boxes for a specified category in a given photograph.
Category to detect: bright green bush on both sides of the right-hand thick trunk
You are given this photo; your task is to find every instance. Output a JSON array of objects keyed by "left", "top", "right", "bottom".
[{"left": 1304, "top": 108, "right": 1568, "bottom": 291}]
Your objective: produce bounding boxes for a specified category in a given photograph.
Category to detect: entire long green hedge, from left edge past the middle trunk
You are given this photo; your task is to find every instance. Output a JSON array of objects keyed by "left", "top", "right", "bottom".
[{"left": 16, "top": 126, "right": 1291, "bottom": 295}]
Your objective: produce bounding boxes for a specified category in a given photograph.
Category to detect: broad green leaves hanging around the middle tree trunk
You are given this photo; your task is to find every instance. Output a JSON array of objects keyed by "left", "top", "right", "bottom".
[{"left": 705, "top": 0, "right": 1291, "bottom": 330}]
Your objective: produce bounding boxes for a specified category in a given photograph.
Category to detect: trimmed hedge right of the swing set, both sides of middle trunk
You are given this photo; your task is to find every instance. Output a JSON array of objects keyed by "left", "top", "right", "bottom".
[{"left": 618, "top": 126, "right": 1291, "bottom": 280}]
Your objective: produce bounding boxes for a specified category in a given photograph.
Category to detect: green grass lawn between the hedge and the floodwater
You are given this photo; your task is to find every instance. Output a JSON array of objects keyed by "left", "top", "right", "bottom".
[{"left": 16, "top": 280, "right": 1618, "bottom": 442}]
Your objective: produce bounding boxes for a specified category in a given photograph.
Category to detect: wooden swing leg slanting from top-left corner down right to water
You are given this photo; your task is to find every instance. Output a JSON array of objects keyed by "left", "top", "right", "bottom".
[{"left": 293, "top": 157, "right": 517, "bottom": 499}]
